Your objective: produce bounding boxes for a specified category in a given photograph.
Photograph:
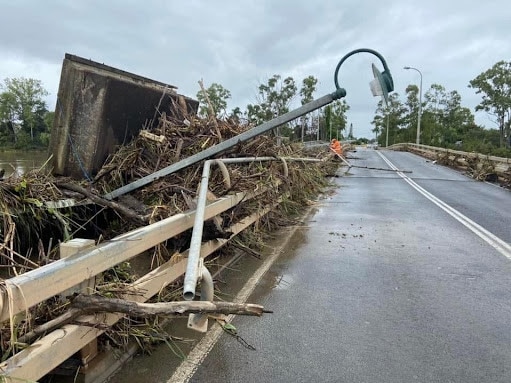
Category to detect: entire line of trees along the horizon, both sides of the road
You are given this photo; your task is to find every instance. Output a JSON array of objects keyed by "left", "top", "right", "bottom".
[{"left": 0, "top": 61, "right": 511, "bottom": 157}]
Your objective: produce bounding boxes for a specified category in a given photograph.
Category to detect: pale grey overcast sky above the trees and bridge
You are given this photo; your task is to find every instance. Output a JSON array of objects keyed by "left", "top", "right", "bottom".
[{"left": 0, "top": 0, "right": 511, "bottom": 137}]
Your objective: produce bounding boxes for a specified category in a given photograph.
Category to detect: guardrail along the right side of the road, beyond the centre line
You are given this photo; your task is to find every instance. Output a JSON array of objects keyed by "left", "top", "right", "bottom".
[{"left": 388, "top": 143, "right": 511, "bottom": 182}]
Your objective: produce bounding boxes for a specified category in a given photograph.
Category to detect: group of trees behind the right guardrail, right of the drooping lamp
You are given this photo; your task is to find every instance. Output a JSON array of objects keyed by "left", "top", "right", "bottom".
[{"left": 372, "top": 61, "right": 511, "bottom": 157}]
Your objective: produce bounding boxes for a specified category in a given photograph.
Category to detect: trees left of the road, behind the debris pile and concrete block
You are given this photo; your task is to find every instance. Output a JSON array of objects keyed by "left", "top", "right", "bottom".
[{"left": 0, "top": 74, "right": 349, "bottom": 150}]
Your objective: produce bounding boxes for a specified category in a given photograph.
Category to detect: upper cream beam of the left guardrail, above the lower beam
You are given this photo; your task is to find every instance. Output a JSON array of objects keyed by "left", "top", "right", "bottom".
[{"left": 0, "top": 193, "right": 250, "bottom": 322}]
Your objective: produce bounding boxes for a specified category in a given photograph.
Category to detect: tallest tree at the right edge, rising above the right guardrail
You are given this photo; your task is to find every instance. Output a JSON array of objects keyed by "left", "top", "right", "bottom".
[{"left": 469, "top": 61, "right": 511, "bottom": 147}]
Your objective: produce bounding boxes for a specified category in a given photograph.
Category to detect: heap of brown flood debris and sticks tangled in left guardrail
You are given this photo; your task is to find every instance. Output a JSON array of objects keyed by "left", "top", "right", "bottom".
[{"left": 0, "top": 103, "right": 339, "bottom": 358}]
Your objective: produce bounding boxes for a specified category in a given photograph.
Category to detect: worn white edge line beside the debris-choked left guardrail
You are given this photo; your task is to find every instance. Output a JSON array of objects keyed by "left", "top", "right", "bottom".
[{"left": 167, "top": 225, "right": 302, "bottom": 383}]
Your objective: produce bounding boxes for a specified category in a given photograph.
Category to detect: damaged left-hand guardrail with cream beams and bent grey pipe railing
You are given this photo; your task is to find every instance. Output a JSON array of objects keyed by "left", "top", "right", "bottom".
[{"left": 0, "top": 157, "right": 321, "bottom": 382}]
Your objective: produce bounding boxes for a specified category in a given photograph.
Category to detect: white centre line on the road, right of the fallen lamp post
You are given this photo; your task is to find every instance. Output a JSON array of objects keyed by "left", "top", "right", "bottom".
[{"left": 377, "top": 152, "right": 511, "bottom": 259}]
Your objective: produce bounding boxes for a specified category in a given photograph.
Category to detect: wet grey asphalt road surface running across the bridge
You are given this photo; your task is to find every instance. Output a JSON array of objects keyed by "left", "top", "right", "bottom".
[{"left": 186, "top": 150, "right": 511, "bottom": 383}]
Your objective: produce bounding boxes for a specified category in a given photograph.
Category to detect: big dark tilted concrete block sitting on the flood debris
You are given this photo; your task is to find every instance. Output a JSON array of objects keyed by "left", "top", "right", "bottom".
[{"left": 49, "top": 54, "right": 199, "bottom": 179}]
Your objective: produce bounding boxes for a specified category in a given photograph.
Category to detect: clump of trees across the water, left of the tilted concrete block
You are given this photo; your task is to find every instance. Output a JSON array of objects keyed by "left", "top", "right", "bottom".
[{"left": 0, "top": 78, "right": 53, "bottom": 150}]
